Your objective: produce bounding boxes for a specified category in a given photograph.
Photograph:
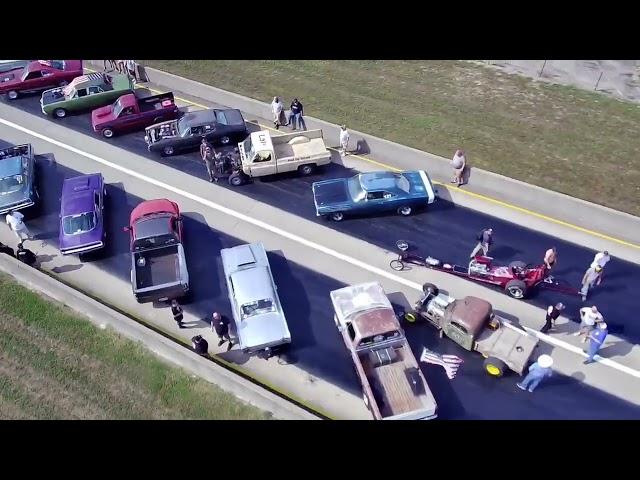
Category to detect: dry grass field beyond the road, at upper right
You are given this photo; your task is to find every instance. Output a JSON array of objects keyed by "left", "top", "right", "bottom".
[{"left": 144, "top": 60, "right": 640, "bottom": 215}]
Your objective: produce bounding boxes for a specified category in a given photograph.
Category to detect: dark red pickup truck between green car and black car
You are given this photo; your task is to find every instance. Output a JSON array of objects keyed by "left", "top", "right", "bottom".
[{"left": 91, "top": 92, "right": 180, "bottom": 138}]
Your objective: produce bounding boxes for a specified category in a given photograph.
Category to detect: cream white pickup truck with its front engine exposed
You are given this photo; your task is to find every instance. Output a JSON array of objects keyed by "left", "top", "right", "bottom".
[{"left": 219, "top": 130, "right": 331, "bottom": 186}]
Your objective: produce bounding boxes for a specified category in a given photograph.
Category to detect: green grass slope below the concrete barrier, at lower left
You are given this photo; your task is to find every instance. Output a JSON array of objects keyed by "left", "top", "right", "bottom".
[{"left": 0, "top": 274, "right": 268, "bottom": 420}]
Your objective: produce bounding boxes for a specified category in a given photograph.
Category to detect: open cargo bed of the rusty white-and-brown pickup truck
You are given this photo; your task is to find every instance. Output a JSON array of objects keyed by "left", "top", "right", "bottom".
[{"left": 358, "top": 345, "right": 430, "bottom": 418}]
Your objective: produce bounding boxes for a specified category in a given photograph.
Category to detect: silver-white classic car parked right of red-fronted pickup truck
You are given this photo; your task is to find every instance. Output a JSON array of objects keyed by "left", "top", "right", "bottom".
[{"left": 220, "top": 243, "right": 291, "bottom": 358}]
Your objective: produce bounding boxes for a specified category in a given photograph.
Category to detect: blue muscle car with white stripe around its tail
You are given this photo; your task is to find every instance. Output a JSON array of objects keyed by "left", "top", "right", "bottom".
[{"left": 312, "top": 170, "right": 436, "bottom": 222}]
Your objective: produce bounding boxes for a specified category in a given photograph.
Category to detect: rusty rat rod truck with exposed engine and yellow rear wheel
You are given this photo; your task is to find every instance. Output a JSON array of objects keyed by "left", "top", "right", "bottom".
[{"left": 404, "top": 283, "right": 538, "bottom": 377}]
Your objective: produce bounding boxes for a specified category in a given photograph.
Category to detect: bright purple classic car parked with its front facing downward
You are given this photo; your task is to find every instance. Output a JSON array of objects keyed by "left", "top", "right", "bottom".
[{"left": 60, "top": 173, "right": 106, "bottom": 255}]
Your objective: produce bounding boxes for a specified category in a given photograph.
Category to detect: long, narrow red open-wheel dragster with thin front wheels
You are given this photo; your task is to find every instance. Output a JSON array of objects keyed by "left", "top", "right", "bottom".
[{"left": 389, "top": 240, "right": 579, "bottom": 299}]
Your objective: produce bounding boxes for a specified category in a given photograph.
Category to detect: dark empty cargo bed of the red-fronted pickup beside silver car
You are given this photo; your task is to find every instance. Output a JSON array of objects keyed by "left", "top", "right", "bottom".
[{"left": 134, "top": 245, "right": 180, "bottom": 290}]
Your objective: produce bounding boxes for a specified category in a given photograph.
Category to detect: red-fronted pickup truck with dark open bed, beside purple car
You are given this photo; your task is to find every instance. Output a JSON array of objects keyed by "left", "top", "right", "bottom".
[{"left": 124, "top": 198, "right": 189, "bottom": 303}]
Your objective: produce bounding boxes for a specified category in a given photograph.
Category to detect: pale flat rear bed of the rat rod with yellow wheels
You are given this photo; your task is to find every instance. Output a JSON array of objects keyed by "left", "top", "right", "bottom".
[{"left": 476, "top": 323, "right": 538, "bottom": 374}]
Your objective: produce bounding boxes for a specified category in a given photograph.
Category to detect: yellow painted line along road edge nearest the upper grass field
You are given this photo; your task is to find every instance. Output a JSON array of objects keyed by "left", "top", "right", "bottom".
[{"left": 85, "top": 68, "right": 640, "bottom": 250}]
